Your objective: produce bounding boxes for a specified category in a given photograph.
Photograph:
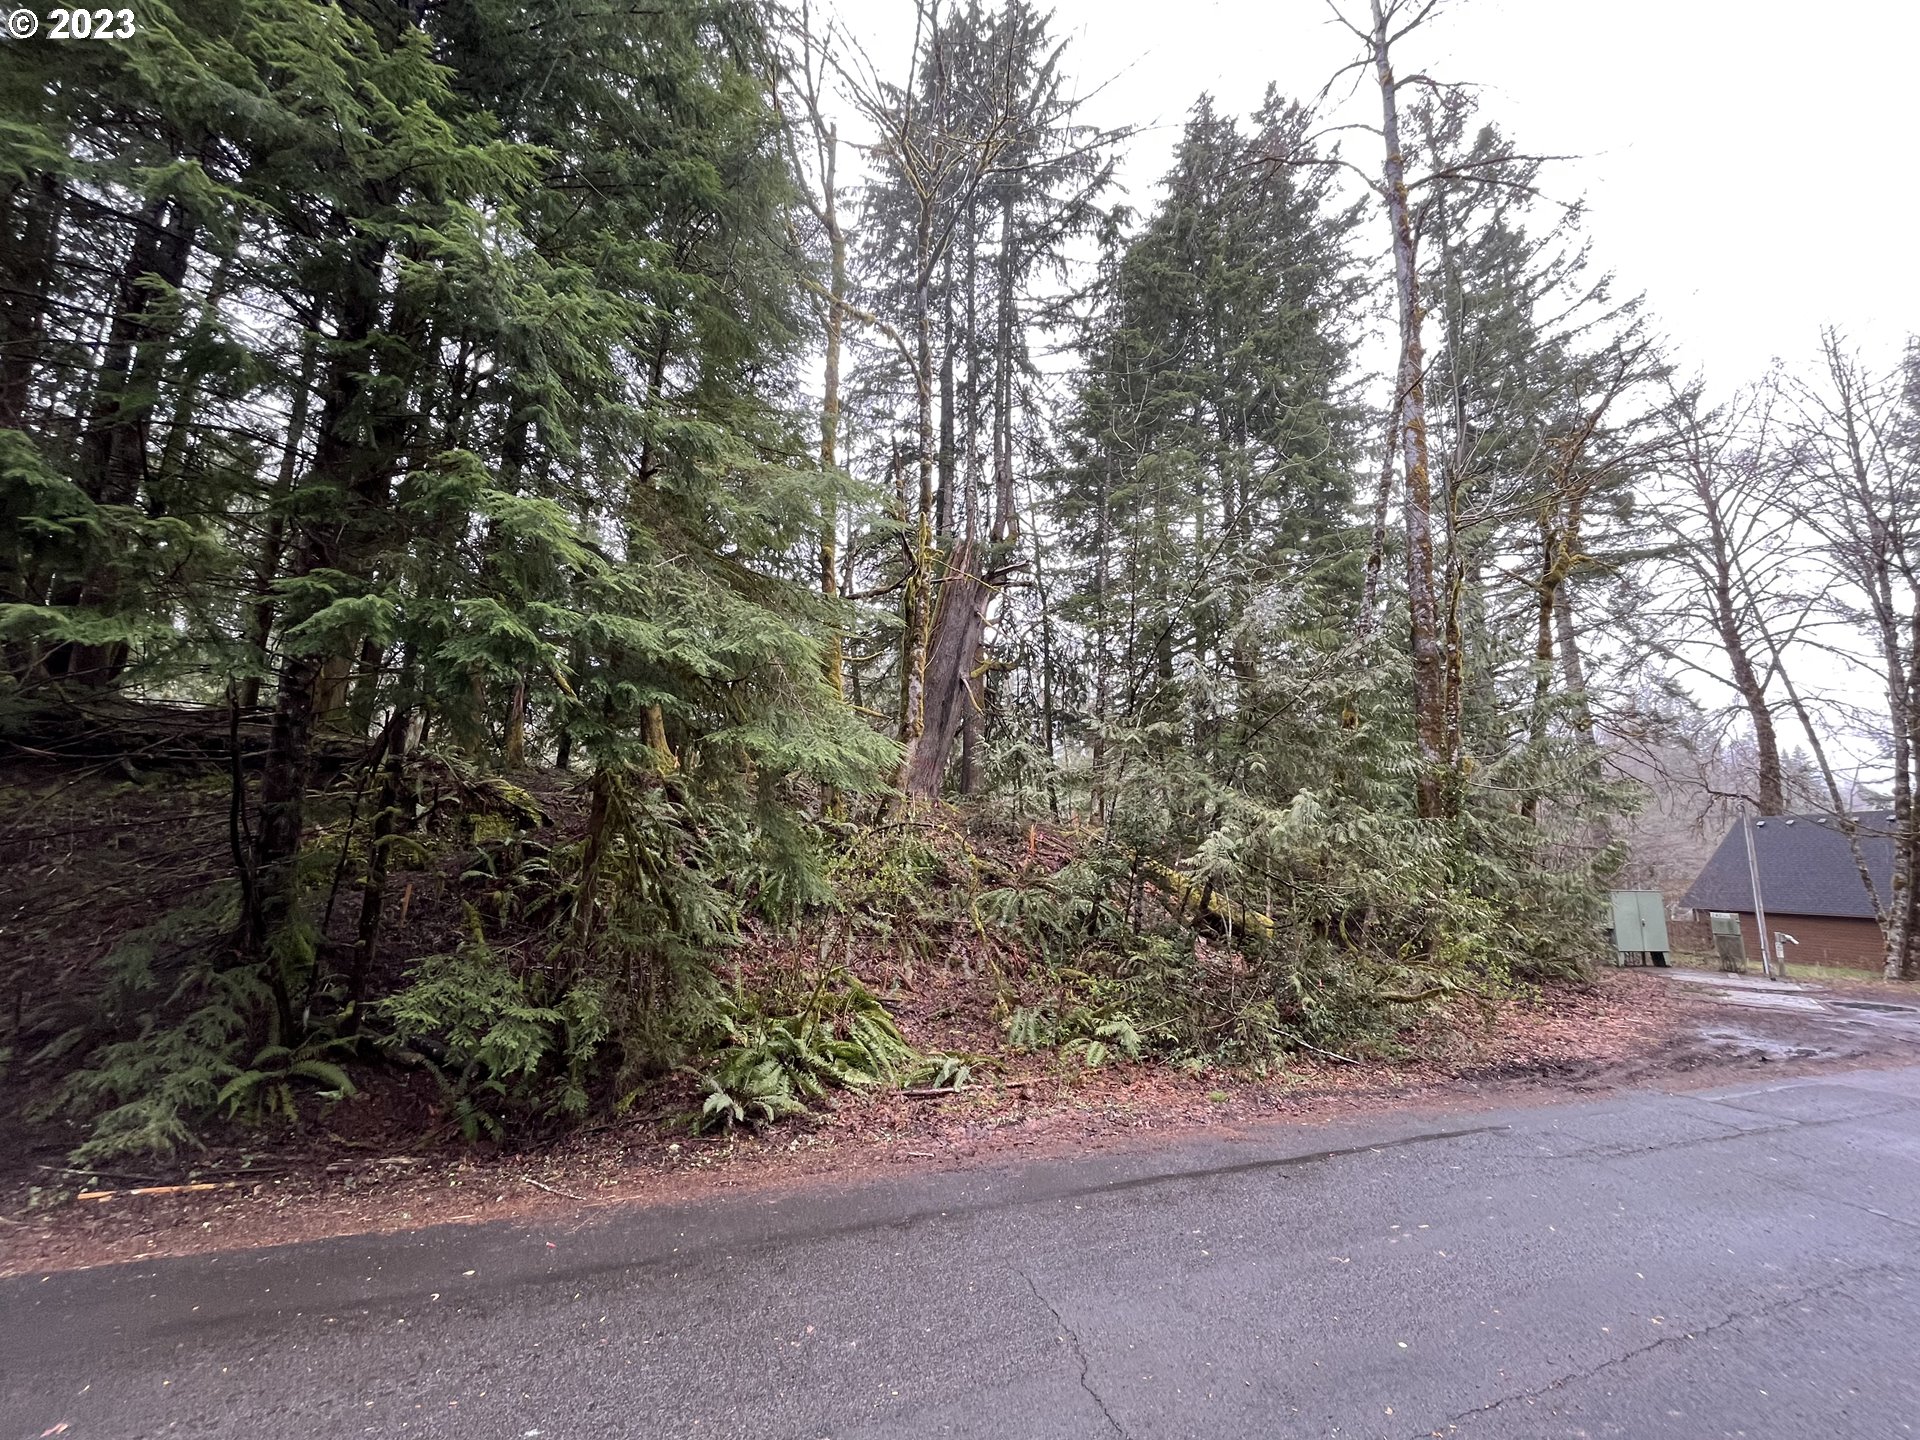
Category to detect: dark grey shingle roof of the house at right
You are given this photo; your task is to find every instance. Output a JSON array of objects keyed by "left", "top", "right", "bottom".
[{"left": 1680, "top": 810, "right": 1893, "bottom": 920}]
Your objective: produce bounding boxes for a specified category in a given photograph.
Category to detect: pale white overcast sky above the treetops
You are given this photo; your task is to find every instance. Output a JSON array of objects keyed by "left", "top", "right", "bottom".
[{"left": 831, "top": 0, "right": 1920, "bottom": 392}]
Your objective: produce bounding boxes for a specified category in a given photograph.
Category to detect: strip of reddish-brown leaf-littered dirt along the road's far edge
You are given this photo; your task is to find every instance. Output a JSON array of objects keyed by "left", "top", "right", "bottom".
[{"left": 0, "top": 972, "right": 1920, "bottom": 1275}]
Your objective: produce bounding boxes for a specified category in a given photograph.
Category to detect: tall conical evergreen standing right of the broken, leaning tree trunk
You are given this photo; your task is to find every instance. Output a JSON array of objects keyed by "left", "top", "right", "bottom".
[{"left": 1058, "top": 94, "right": 1359, "bottom": 760}]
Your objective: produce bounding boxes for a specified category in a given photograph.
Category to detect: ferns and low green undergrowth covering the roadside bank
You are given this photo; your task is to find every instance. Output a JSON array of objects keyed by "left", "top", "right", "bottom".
[{"left": 18, "top": 748, "right": 1584, "bottom": 1167}]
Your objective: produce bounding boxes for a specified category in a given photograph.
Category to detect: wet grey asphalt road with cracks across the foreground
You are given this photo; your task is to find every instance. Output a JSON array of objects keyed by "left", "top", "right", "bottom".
[{"left": 0, "top": 1069, "right": 1920, "bottom": 1440}]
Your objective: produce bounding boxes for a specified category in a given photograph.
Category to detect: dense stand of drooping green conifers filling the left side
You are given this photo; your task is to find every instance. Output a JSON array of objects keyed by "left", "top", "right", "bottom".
[{"left": 0, "top": 0, "right": 891, "bottom": 1159}]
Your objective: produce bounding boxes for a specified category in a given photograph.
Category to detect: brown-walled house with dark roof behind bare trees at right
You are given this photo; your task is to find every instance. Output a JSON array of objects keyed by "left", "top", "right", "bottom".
[{"left": 1680, "top": 810, "right": 1893, "bottom": 970}]
